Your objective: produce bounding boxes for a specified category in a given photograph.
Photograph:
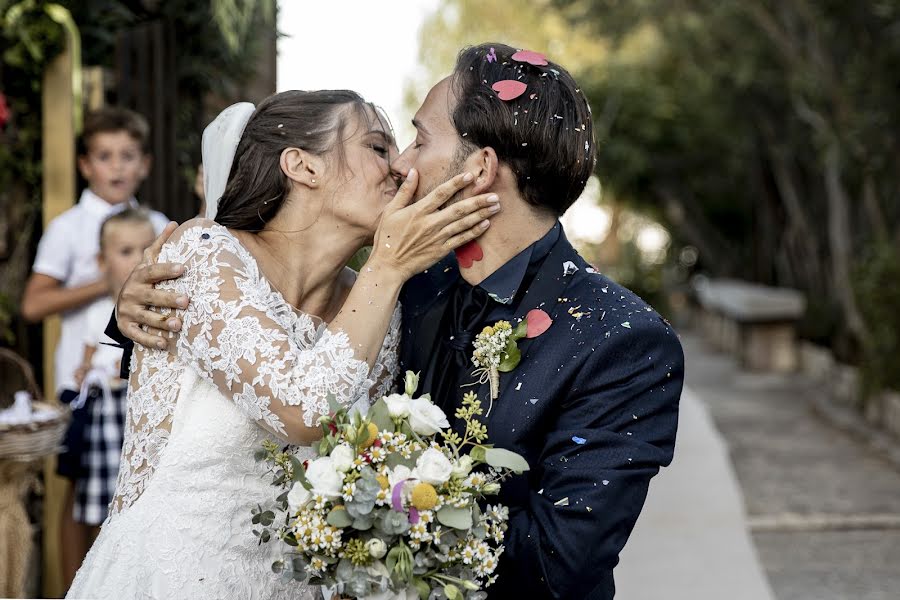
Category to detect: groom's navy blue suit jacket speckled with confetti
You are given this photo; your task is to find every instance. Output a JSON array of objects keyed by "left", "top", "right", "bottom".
[{"left": 401, "top": 226, "right": 684, "bottom": 600}]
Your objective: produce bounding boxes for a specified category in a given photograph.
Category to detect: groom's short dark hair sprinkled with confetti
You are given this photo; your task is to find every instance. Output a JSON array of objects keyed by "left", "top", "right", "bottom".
[{"left": 451, "top": 43, "right": 596, "bottom": 216}]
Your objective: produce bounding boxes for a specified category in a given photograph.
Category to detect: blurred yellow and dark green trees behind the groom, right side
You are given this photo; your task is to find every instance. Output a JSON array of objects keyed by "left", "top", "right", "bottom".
[{"left": 410, "top": 0, "right": 900, "bottom": 394}]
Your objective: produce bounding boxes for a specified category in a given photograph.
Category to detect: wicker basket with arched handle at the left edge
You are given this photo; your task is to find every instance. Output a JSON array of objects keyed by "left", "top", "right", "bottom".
[{"left": 0, "top": 348, "right": 71, "bottom": 460}]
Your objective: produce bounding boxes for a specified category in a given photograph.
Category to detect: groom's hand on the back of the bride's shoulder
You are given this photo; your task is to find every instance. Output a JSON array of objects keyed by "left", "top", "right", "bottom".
[{"left": 116, "top": 223, "right": 190, "bottom": 350}]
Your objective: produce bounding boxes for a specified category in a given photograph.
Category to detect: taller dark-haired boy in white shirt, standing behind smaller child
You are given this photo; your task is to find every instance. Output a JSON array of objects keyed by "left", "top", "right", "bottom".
[{"left": 22, "top": 108, "right": 168, "bottom": 586}]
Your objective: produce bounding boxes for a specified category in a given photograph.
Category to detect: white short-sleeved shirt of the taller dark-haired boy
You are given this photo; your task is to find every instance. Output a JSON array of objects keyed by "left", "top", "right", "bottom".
[{"left": 33, "top": 189, "right": 169, "bottom": 391}]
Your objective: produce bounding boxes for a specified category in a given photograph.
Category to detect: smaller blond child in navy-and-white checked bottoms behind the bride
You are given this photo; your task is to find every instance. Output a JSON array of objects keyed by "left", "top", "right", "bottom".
[{"left": 71, "top": 208, "right": 156, "bottom": 539}]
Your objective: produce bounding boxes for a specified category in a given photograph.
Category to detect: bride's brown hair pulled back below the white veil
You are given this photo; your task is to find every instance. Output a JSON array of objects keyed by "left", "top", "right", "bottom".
[{"left": 216, "top": 90, "right": 377, "bottom": 231}]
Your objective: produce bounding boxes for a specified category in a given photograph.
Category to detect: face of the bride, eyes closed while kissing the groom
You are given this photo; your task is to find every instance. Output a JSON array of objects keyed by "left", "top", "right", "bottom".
[{"left": 326, "top": 107, "right": 398, "bottom": 236}]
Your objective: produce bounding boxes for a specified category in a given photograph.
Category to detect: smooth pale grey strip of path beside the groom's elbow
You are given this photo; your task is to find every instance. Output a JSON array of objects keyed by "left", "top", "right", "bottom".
[{"left": 615, "top": 388, "right": 775, "bottom": 600}]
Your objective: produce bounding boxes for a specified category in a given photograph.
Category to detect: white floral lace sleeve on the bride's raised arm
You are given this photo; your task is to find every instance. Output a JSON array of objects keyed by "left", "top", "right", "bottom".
[{"left": 159, "top": 220, "right": 369, "bottom": 442}]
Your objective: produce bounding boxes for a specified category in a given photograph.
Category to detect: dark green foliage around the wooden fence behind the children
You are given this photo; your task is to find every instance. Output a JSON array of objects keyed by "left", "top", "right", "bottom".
[{"left": 0, "top": 0, "right": 276, "bottom": 346}]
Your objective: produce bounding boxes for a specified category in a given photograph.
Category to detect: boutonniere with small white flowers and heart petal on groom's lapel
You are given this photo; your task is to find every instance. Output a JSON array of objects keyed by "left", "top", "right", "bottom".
[{"left": 470, "top": 308, "right": 553, "bottom": 416}]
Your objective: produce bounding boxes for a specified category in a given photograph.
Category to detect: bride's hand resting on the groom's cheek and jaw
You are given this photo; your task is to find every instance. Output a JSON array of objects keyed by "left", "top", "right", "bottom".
[{"left": 369, "top": 170, "right": 500, "bottom": 281}]
